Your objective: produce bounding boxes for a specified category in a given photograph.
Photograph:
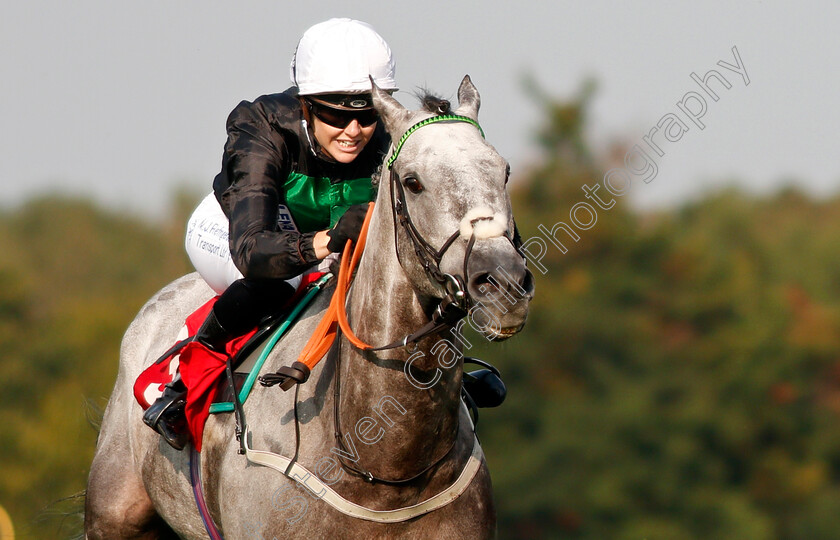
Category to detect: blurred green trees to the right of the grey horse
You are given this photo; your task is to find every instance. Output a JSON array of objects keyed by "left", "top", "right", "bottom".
[{"left": 472, "top": 85, "right": 840, "bottom": 540}]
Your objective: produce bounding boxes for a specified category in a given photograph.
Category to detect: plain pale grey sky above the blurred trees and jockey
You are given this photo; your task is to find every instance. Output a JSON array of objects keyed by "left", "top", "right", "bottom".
[{"left": 0, "top": 0, "right": 840, "bottom": 217}]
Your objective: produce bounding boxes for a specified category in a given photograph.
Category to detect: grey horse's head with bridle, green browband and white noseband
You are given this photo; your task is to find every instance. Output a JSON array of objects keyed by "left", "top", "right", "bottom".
[{"left": 373, "top": 76, "right": 534, "bottom": 340}]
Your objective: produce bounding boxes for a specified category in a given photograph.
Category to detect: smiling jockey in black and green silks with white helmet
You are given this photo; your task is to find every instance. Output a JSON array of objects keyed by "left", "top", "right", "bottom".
[{"left": 143, "top": 19, "right": 506, "bottom": 450}]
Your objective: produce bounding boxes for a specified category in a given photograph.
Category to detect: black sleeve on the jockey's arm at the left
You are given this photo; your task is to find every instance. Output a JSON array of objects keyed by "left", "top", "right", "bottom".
[{"left": 221, "top": 102, "right": 318, "bottom": 279}]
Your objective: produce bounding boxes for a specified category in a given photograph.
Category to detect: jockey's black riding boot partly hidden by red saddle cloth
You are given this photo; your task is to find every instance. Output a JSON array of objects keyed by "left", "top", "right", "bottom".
[{"left": 143, "top": 310, "right": 233, "bottom": 450}]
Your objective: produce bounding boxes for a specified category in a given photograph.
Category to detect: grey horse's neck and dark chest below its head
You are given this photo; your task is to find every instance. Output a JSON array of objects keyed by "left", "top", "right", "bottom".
[{"left": 341, "top": 203, "right": 461, "bottom": 477}]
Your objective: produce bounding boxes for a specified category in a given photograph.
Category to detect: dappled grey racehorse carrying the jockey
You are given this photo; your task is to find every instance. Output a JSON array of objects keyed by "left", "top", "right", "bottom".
[{"left": 85, "top": 77, "right": 533, "bottom": 540}]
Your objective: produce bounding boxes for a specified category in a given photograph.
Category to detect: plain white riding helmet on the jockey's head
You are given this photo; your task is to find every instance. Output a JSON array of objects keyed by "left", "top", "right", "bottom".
[{"left": 289, "top": 19, "right": 397, "bottom": 96}]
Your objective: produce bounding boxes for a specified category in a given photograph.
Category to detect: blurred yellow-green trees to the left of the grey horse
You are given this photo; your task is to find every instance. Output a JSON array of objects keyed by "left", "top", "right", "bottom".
[{"left": 0, "top": 193, "right": 190, "bottom": 538}]
